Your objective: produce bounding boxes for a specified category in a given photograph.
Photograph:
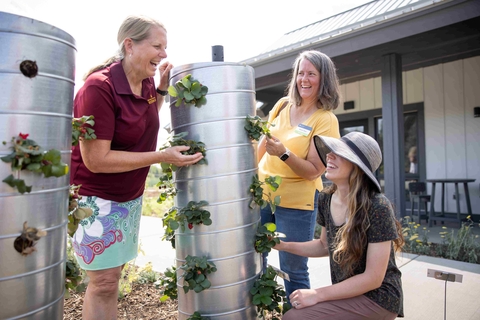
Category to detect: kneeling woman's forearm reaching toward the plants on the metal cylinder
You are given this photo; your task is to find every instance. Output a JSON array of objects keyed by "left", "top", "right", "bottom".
[{"left": 273, "top": 227, "right": 328, "bottom": 258}]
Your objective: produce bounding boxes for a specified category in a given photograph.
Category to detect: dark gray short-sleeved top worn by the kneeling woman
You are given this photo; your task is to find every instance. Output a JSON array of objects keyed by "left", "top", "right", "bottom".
[{"left": 317, "top": 192, "right": 403, "bottom": 317}]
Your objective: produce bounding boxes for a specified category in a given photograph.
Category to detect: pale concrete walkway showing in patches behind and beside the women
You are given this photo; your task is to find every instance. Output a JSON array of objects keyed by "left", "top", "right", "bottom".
[{"left": 135, "top": 216, "right": 480, "bottom": 320}]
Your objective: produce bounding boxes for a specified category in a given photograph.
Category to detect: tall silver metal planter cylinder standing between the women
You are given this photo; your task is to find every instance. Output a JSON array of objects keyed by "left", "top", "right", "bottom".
[{"left": 170, "top": 62, "right": 262, "bottom": 320}]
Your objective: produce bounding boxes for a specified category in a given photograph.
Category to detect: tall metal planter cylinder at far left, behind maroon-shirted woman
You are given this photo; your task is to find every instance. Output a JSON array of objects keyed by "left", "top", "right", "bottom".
[{"left": 0, "top": 12, "right": 76, "bottom": 319}]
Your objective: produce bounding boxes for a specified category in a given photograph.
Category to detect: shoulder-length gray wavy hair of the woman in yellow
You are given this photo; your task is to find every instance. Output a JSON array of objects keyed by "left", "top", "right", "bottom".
[{"left": 287, "top": 50, "right": 340, "bottom": 110}]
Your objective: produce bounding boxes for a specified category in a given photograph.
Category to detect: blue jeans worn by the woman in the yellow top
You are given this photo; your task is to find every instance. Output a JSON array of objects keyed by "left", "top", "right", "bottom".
[{"left": 260, "top": 191, "right": 318, "bottom": 299}]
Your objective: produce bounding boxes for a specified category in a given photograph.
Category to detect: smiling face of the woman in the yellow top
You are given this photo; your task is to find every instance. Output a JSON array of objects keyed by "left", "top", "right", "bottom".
[{"left": 296, "top": 59, "right": 320, "bottom": 101}]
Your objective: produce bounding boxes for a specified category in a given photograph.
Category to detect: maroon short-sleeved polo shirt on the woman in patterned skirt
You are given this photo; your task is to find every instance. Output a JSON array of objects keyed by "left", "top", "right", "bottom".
[{"left": 70, "top": 62, "right": 160, "bottom": 202}]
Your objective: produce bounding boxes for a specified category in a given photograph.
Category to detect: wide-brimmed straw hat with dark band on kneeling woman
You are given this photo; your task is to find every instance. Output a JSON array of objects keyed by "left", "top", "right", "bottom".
[{"left": 313, "top": 131, "right": 382, "bottom": 192}]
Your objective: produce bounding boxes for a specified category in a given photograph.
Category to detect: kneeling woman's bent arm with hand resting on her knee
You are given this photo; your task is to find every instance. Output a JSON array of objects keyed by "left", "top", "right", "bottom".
[{"left": 290, "top": 241, "right": 391, "bottom": 308}]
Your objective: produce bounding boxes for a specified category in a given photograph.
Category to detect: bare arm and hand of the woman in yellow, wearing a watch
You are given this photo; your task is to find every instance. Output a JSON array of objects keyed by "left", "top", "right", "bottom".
[{"left": 259, "top": 136, "right": 325, "bottom": 180}]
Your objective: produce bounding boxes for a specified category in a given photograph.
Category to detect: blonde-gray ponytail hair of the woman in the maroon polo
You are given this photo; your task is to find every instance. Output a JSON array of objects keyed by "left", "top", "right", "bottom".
[{"left": 83, "top": 16, "right": 167, "bottom": 80}]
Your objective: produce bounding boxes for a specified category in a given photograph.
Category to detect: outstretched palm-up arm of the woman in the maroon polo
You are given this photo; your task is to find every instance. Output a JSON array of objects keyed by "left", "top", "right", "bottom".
[{"left": 80, "top": 139, "right": 203, "bottom": 173}]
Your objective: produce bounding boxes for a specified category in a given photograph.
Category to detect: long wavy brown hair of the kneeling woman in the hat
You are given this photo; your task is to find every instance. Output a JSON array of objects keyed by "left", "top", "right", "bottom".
[{"left": 326, "top": 165, "right": 405, "bottom": 276}]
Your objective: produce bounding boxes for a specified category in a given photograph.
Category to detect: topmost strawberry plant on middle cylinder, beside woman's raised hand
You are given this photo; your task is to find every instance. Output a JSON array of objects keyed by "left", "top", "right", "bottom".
[{"left": 168, "top": 74, "right": 208, "bottom": 107}]
